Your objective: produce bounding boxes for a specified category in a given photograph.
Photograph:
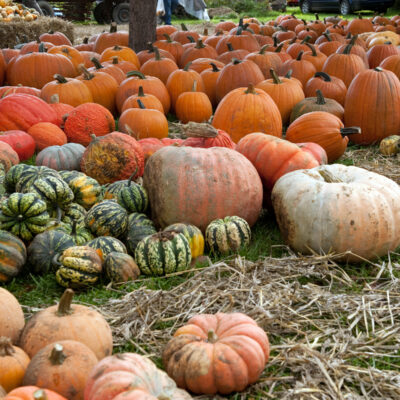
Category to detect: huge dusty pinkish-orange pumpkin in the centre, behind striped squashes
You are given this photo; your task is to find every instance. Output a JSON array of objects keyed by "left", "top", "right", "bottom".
[{"left": 143, "top": 146, "right": 262, "bottom": 232}]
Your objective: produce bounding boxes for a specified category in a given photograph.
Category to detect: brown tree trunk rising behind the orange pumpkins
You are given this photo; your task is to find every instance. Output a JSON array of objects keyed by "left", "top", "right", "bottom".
[{"left": 129, "top": 0, "right": 157, "bottom": 52}]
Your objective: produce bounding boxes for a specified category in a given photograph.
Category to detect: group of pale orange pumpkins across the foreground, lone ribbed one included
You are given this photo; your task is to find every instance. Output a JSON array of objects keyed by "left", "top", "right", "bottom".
[{"left": 0, "top": 288, "right": 269, "bottom": 400}]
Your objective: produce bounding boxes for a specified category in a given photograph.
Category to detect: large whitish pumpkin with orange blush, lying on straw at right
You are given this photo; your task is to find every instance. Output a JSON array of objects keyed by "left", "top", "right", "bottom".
[{"left": 272, "top": 164, "right": 400, "bottom": 262}]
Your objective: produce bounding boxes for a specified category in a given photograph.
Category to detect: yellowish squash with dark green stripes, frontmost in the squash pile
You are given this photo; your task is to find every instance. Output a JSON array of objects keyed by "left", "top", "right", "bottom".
[{"left": 56, "top": 246, "right": 102, "bottom": 289}]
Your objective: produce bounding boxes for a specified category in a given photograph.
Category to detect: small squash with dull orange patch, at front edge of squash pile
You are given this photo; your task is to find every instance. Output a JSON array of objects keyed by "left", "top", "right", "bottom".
[{"left": 104, "top": 251, "right": 140, "bottom": 282}]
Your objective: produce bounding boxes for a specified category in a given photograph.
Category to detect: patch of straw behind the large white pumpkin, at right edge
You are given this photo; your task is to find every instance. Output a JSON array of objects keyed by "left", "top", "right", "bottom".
[{"left": 344, "top": 146, "right": 400, "bottom": 184}]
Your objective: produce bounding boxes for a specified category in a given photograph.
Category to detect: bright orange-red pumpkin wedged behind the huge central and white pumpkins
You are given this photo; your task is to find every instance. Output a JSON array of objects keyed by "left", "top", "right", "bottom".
[{"left": 236, "top": 133, "right": 318, "bottom": 196}]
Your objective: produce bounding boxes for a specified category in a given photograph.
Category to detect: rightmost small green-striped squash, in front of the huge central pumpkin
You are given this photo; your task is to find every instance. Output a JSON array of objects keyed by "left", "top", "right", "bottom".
[{"left": 205, "top": 216, "right": 251, "bottom": 254}]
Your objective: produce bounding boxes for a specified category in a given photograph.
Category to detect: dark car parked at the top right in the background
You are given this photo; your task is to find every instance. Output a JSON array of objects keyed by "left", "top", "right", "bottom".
[{"left": 299, "top": 0, "right": 394, "bottom": 15}]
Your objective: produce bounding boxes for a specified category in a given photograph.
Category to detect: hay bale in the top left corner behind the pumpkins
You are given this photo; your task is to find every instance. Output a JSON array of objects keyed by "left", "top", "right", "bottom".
[{"left": 0, "top": 17, "right": 74, "bottom": 48}]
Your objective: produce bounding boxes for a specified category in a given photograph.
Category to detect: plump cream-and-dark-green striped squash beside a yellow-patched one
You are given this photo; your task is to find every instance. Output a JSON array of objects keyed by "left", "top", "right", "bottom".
[{"left": 135, "top": 231, "right": 192, "bottom": 276}]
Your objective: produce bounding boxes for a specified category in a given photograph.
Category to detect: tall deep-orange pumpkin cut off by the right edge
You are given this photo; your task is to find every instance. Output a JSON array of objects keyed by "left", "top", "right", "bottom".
[{"left": 344, "top": 70, "right": 400, "bottom": 144}]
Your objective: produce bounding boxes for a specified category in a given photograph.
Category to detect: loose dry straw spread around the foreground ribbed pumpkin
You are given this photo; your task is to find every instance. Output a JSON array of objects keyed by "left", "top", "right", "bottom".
[{"left": 100, "top": 254, "right": 400, "bottom": 400}]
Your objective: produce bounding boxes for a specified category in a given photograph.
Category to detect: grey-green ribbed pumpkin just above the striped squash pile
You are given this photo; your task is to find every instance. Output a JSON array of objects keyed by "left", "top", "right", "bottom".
[{"left": 35, "top": 143, "right": 85, "bottom": 171}]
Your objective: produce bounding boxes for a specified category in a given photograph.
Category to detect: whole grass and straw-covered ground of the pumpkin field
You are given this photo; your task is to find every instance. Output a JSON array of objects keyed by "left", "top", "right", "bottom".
[{"left": 2, "top": 8, "right": 400, "bottom": 400}]
